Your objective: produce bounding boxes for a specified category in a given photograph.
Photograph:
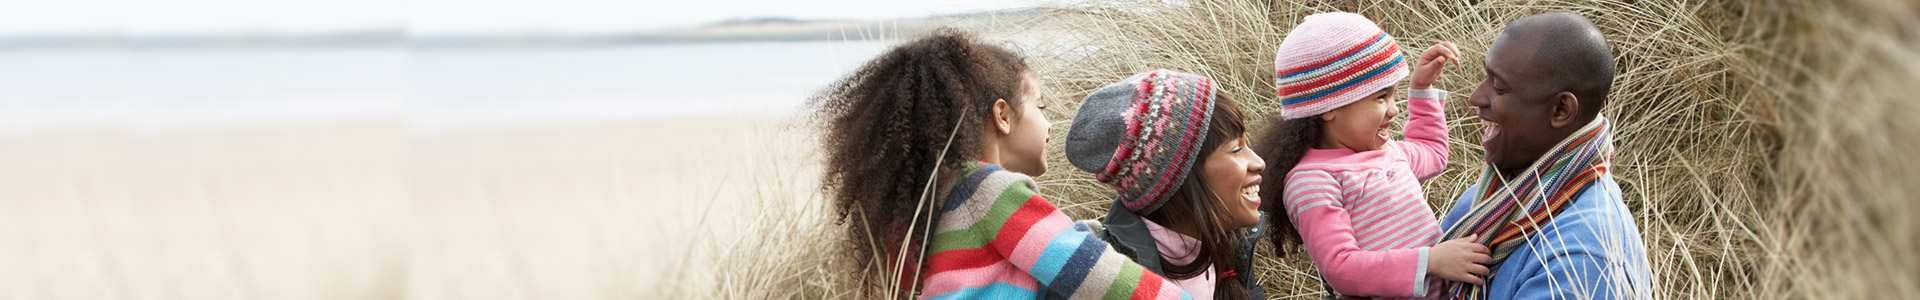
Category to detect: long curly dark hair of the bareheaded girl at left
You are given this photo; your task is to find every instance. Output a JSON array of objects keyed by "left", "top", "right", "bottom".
[{"left": 806, "top": 29, "right": 1037, "bottom": 290}]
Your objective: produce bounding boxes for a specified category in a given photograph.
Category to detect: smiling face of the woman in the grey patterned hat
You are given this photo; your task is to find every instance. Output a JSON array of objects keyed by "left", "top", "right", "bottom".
[{"left": 1202, "top": 137, "right": 1267, "bottom": 229}]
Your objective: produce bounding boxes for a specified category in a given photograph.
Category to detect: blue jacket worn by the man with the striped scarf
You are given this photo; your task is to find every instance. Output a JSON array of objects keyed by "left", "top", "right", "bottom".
[{"left": 1440, "top": 175, "right": 1653, "bottom": 300}]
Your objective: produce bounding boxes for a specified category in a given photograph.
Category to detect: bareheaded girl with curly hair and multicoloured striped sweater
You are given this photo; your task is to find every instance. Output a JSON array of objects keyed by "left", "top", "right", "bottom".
[{"left": 808, "top": 29, "right": 1188, "bottom": 300}]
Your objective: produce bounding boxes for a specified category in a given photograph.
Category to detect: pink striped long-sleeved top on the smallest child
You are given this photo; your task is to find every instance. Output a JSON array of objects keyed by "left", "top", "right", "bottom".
[{"left": 1283, "top": 90, "right": 1448, "bottom": 298}]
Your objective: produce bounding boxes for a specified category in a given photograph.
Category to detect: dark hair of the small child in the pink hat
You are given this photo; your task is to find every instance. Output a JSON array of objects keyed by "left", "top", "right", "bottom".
[{"left": 1254, "top": 115, "right": 1327, "bottom": 256}]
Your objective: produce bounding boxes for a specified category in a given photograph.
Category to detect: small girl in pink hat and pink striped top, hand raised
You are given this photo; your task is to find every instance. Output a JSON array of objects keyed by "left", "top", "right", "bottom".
[{"left": 1258, "top": 13, "right": 1488, "bottom": 298}]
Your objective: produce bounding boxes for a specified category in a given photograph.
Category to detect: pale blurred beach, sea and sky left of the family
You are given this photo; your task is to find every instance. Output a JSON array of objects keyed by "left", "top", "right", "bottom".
[{"left": 0, "top": 0, "right": 1023, "bottom": 300}]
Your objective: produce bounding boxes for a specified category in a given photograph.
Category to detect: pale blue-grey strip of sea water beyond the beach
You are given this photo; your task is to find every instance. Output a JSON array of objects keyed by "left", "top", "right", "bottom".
[{"left": 0, "top": 40, "right": 891, "bottom": 131}]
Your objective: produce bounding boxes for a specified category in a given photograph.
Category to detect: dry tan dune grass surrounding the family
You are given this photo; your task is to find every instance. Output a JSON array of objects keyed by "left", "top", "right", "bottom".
[{"left": 674, "top": 0, "right": 1920, "bottom": 298}]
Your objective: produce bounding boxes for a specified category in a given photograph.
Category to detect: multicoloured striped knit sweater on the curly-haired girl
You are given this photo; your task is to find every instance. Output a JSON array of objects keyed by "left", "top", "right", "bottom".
[{"left": 922, "top": 162, "right": 1190, "bottom": 300}]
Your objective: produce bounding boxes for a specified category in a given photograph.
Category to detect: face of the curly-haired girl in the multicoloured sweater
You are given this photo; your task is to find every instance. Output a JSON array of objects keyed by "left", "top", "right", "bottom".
[{"left": 1000, "top": 71, "right": 1052, "bottom": 177}]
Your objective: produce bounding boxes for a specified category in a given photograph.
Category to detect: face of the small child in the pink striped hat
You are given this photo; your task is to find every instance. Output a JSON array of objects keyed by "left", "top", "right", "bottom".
[{"left": 1315, "top": 87, "right": 1400, "bottom": 152}]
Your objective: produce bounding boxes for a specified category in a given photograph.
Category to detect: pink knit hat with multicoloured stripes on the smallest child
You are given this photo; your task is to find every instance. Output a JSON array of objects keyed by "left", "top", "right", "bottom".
[{"left": 1273, "top": 12, "right": 1407, "bottom": 119}]
